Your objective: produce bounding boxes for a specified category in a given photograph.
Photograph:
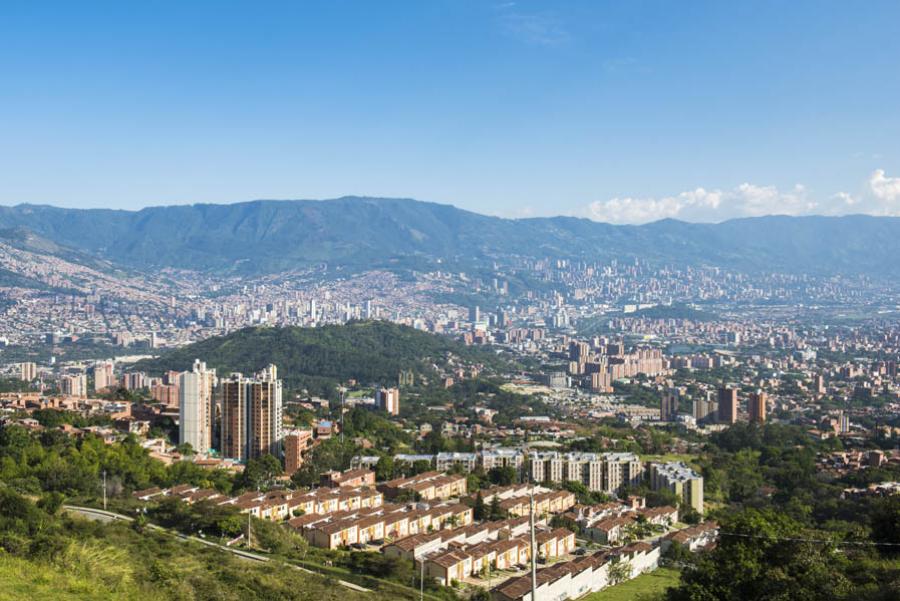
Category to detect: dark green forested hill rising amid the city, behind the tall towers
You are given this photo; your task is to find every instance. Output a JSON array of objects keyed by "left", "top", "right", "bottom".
[{"left": 134, "top": 321, "right": 503, "bottom": 392}]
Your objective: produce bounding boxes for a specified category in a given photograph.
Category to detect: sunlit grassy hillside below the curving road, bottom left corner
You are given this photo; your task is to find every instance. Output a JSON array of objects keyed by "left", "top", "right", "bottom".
[{"left": 0, "top": 486, "right": 366, "bottom": 601}]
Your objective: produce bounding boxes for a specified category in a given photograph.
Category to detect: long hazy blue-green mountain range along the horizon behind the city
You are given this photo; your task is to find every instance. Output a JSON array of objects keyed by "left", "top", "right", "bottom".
[{"left": 0, "top": 197, "right": 900, "bottom": 275}]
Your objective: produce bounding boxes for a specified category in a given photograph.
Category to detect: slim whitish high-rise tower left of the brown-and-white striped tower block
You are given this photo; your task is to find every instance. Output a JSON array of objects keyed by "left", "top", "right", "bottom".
[{"left": 178, "top": 359, "right": 216, "bottom": 454}]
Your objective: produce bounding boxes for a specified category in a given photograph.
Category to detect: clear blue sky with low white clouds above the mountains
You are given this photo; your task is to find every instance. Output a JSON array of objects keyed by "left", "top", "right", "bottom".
[{"left": 0, "top": 0, "right": 900, "bottom": 223}]
